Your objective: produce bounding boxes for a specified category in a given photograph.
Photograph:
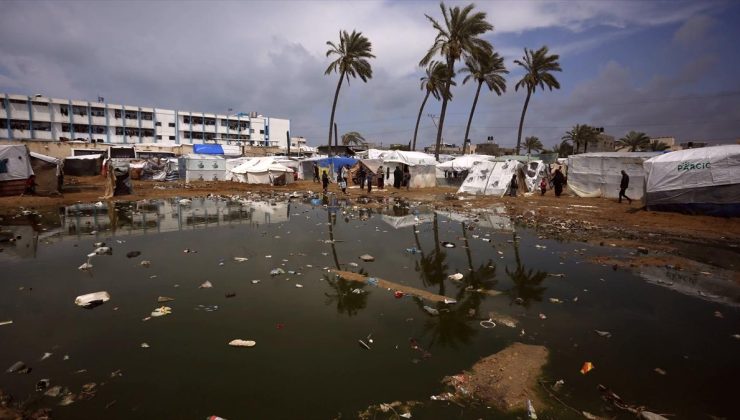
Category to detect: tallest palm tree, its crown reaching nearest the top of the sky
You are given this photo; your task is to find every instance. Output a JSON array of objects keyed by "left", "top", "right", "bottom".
[{"left": 419, "top": 2, "right": 493, "bottom": 160}]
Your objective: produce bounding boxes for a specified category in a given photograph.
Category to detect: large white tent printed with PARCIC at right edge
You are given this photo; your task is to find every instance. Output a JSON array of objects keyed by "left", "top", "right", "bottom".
[{"left": 640, "top": 145, "right": 740, "bottom": 216}]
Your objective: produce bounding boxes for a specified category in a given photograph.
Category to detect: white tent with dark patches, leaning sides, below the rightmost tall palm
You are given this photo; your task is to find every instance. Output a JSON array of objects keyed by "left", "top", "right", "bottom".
[{"left": 457, "top": 160, "right": 526, "bottom": 197}]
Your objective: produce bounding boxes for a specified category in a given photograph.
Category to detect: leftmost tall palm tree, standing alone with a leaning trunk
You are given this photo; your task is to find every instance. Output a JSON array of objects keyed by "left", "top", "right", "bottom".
[{"left": 324, "top": 30, "right": 375, "bottom": 154}]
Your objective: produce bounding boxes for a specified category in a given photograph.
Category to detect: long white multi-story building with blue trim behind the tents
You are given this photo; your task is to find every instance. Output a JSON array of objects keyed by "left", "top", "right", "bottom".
[{"left": 0, "top": 93, "right": 290, "bottom": 148}]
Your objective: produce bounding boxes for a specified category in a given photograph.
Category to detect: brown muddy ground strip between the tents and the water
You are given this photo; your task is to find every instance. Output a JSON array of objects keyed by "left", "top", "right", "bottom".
[{"left": 0, "top": 177, "right": 740, "bottom": 283}]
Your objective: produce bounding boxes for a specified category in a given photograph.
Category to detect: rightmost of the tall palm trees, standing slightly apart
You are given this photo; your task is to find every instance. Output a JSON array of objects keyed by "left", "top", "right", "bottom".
[{"left": 514, "top": 45, "right": 563, "bottom": 154}]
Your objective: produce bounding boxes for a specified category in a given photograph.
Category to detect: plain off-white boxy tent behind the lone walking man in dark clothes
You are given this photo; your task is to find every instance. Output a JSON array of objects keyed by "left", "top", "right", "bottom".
[{"left": 568, "top": 152, "right": 660, "bottom": 200}]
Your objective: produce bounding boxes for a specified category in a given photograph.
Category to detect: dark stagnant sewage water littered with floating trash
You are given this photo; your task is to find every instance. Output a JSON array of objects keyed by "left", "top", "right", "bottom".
[{"left": 0, "top": 197, "right": 740, "bottom": 419}]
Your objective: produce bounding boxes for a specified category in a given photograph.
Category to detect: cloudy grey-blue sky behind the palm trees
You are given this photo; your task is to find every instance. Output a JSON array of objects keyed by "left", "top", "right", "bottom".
[{"left": 0, "top": 0, "right": 740, "bottom": 146}]
